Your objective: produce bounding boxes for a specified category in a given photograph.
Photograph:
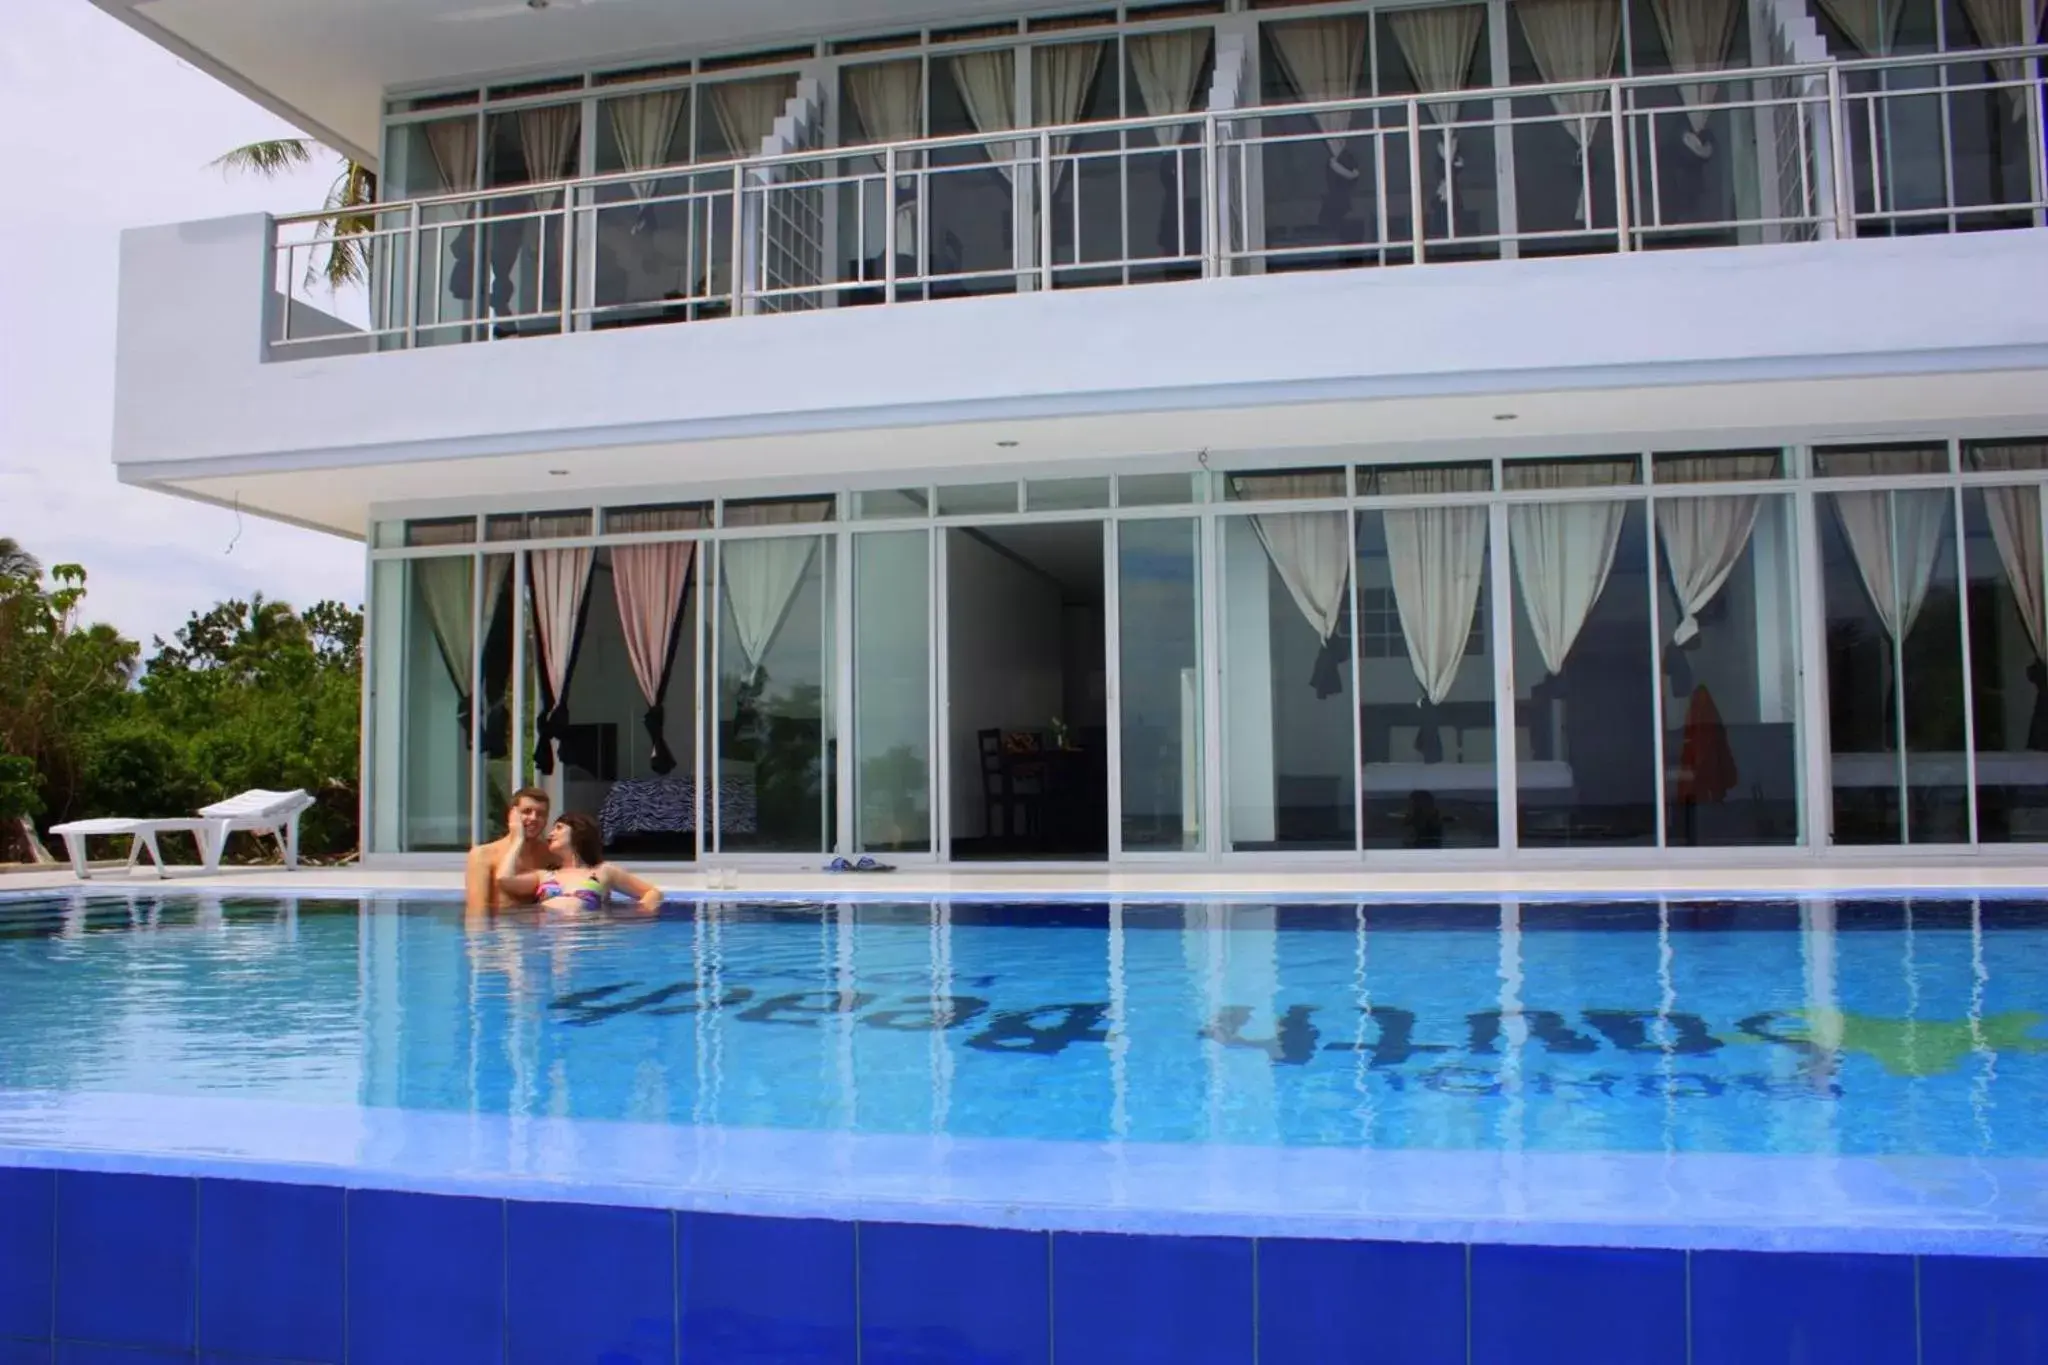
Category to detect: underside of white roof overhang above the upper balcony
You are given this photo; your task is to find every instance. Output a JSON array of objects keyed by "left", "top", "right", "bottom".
[{"left": 94, "top": 0, "right": 1075, "bottom": 160}]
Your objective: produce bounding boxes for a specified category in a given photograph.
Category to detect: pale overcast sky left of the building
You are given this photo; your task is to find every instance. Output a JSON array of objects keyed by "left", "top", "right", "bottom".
[{"left": 0, "top": 0, "right": 362, "bottom": 645}]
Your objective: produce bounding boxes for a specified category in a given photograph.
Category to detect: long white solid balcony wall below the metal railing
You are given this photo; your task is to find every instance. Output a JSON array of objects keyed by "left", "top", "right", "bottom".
[{"left": 115, "top": 217, "right": 2048, "bottom": 495}]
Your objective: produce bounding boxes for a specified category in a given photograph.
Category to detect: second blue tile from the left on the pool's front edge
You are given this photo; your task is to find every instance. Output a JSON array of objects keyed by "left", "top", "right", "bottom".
[{"left": 57, "top": 1171, "right": 199, "bottom": 1351}]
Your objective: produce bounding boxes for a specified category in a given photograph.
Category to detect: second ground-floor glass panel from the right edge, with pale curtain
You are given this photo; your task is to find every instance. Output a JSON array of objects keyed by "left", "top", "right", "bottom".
[{"left": 1819, "top": 489, "right": 1970, "bottom": 843}]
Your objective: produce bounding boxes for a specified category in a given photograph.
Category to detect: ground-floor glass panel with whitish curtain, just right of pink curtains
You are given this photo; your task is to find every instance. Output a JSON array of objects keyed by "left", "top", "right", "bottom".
[{"left": 717, "top": 536, "right": 836, "bottom": 853}]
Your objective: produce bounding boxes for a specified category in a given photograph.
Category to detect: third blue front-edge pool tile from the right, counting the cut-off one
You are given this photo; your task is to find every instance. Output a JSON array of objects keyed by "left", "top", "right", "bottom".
[{"left": 1470, "top": 1246, "right": 1679, "bottom": 1365}]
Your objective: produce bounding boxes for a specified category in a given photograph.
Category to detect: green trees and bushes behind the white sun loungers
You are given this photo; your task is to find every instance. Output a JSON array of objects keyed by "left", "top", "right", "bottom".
[{"left": 0, "top": 540, "right": 362, "bottom": 860}]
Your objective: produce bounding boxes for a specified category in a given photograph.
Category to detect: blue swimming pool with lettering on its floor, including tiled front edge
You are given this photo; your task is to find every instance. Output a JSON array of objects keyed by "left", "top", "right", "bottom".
[{"left": 0, "top": 890, "right": 2048, "bottom": 1365}]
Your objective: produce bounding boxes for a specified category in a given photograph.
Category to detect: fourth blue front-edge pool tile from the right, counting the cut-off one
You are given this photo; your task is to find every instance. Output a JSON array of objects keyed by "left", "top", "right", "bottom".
[{"left": 1260, "top": 1238, "right": 1464, "bottom": 1365}]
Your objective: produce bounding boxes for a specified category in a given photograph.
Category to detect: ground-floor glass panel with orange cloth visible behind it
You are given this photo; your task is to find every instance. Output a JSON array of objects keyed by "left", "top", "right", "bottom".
[{"left": 1657, "top": 491, "right": 1798, "bottom": 847}]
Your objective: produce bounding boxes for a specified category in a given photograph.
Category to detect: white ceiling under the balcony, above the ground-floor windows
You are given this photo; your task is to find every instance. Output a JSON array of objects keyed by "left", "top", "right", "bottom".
[{"left": 140, "top": 370, "right": 2048, "bottom": 536}]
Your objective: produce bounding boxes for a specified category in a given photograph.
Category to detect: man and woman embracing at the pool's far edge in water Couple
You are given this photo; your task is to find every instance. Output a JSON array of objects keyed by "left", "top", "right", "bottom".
[{"left": 463, "top": 786, "right": 662, "bottom": 911}]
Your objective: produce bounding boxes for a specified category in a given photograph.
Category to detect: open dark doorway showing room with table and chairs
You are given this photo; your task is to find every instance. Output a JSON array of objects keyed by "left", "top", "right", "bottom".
[{"left": 946, "top": 522, "right": 1110, "bottom": 862}]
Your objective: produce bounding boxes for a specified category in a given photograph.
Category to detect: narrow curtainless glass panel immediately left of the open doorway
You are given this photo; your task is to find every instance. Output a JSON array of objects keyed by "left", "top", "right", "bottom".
[{"left": 854, "top": 530, "right": 932, "bottom": 853}]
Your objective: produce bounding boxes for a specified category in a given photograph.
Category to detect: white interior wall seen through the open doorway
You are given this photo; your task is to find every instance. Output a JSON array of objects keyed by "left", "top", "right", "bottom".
[{"left": 946, "top": 530, "right": 1065, "bottom": 839}]
